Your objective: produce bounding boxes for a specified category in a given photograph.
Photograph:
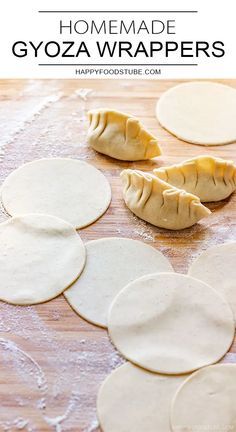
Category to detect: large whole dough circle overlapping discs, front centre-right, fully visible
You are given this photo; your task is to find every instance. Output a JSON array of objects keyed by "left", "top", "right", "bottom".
[{"left": 108, "top": 273, "right": 234, "bottom": 374}]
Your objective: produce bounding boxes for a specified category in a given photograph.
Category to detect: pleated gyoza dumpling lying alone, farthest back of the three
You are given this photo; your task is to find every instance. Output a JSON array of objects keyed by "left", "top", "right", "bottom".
[{"left": 88, "top": 108, "right": 161, "bottom": 161}]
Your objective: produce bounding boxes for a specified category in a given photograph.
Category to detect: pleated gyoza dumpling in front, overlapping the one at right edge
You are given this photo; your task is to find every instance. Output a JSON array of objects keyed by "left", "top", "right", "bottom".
[{"left": 121, "top": 169, "right": 211, "bottom": 230}]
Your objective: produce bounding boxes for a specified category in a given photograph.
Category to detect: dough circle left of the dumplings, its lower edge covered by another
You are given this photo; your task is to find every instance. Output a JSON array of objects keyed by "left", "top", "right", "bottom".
[{"left": 1, "top": 158, "right": 111, "bottom": 228}]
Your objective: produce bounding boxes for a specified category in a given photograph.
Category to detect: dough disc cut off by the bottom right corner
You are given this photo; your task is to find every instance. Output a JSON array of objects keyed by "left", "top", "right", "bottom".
[{"left": 171, "top": 364, "right": 236, "bottom": 432}]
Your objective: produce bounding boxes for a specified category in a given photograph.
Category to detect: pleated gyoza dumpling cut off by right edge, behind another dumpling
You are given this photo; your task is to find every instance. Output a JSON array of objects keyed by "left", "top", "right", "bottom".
[{"left": 153, "top": 156, "right": 236, "bottom": 202}]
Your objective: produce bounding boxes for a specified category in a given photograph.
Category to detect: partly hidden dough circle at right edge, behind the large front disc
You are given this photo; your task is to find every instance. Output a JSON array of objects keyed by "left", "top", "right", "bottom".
[{"left": 189, "top": 243, "right": 236, "bottom": 324}]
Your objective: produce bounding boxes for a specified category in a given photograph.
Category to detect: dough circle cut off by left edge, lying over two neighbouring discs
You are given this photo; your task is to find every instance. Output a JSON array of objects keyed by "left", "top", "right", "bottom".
[{"left": 0, "top": 214, "right": 86, "bottom": 305}]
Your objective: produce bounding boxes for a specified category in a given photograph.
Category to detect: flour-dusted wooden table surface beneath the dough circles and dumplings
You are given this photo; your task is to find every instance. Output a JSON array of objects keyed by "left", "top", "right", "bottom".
[{"left": 0, "top": 80, "right": 236, "bottom": 432}]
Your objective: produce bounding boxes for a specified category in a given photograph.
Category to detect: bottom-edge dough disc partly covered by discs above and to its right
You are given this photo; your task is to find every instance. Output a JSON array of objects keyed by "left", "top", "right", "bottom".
[{"left": 97, "top": 363, "right": 189, "bottom": 432}]
